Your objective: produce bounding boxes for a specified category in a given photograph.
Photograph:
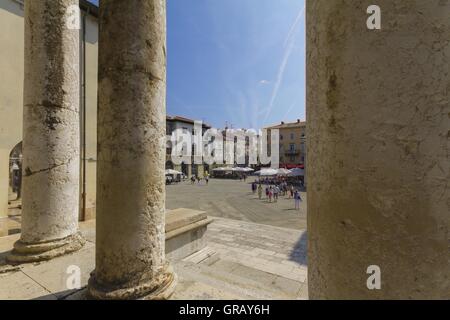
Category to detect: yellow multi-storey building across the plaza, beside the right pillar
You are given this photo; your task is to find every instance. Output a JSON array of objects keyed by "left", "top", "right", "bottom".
[{"left": 266, "top": 120, "right": 306, "bottom": 169}]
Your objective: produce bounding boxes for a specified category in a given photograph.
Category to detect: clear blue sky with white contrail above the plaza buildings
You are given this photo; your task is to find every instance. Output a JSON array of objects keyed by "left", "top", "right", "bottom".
[{"left": 88, "top": 0, "right": 305, "bottom": 129}]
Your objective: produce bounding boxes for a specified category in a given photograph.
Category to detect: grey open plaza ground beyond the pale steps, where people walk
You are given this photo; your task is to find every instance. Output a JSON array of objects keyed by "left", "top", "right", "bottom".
[{"left": 166, "top": 177, "right": 306, "bottom": 230}]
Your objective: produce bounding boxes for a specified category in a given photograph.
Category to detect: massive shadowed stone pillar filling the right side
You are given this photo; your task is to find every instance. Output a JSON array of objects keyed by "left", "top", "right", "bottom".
[{"left": 306, "top": 0, "right": 450, "bottom": 299}]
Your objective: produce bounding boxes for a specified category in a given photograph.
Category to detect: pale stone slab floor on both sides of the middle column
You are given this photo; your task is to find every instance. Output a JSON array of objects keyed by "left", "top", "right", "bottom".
[{"left": 0, "top": 218, "right": 307, "bottom": 300}]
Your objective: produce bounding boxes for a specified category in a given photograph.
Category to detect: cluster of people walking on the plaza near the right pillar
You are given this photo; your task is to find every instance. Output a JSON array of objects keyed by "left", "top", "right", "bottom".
[{"left": 252, "top": 181, "right": 303, "bottom": 210}]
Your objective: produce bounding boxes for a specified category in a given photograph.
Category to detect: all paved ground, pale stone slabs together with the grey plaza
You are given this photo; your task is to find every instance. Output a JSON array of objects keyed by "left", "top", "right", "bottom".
[{"left": 0, "top": 178, "right": 308, "bottom": 300}]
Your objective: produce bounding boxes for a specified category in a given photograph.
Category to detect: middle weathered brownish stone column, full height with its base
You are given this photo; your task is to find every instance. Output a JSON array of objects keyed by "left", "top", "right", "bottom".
[{"left": 89, "top": 0, "right": 176, "bottom": 299}]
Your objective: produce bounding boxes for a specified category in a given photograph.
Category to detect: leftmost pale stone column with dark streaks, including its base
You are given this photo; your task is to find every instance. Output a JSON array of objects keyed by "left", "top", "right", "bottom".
[{"left": 8, "top": 0, "right": 84, "bottom": 262}]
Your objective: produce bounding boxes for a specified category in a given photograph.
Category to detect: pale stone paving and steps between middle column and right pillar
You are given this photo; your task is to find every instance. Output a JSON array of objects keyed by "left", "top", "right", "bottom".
[{"left": 174, "top": 218, "right": 308, "bottom": 299}]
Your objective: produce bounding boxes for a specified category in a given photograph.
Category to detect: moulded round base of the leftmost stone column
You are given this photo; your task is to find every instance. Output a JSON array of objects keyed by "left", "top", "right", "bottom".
[{"left": 6, "top": 232, "right": 86, "bottom": 264}]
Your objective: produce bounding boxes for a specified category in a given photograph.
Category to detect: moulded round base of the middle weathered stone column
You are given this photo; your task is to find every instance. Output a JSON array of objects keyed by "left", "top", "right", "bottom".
[{"left": 88, "top": 265, "right": 178, "bottom": 300}]
